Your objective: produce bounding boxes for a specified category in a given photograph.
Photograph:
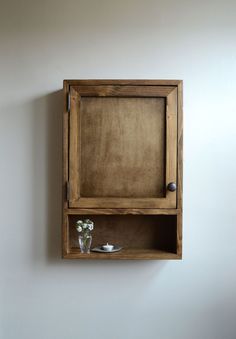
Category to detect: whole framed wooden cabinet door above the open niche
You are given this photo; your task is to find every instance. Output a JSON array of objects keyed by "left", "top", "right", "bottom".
[{"left": 68, "top": 81, "right": 177, "bottom": 208}]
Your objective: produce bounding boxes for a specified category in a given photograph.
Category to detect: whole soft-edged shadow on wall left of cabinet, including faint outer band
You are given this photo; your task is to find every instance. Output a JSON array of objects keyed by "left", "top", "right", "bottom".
[{"left": 32, "top": 90, "right": 63, "bottom": 264}]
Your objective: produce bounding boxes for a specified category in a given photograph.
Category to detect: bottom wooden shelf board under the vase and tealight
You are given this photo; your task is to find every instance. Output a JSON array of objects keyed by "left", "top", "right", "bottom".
[{"left": 64, "top": 248, "right": 181, "bottom": 260}]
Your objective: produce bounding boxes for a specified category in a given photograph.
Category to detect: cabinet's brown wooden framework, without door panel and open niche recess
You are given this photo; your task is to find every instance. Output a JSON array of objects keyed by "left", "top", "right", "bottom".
[{"left": 62, "top": 80, "right": 183, "bottom": 259}]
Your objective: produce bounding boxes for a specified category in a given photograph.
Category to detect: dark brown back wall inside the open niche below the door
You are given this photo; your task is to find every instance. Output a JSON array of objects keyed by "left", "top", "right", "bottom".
[{"left": 69, "top": 215, "right": 177, "bottom": 252}]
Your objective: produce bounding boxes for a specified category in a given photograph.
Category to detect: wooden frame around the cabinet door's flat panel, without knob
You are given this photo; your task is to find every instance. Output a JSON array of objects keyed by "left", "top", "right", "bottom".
[{"left": 68, "top": 85, "right": 177, "bottom": 208}]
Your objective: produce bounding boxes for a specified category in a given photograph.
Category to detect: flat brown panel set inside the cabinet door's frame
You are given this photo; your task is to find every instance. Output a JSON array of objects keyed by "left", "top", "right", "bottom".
[{"left": 80, "top": 97, "right": 166, "bottom": 198}]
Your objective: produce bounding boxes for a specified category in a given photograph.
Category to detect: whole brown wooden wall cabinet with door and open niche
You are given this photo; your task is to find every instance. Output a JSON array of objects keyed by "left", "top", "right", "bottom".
[{"left": 62, "top": 80, "right": 182, "bottom": 259}]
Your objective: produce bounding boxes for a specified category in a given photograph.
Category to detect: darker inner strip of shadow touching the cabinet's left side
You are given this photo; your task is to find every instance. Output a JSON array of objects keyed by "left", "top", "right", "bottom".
[{"left": 46, "top": 90, "right": 63, "bottom": 261}]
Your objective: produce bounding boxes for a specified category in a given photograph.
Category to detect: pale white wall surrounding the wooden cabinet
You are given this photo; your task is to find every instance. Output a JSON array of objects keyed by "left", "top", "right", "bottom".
[{"left": 0, "top": 0, "right": 236, "bottom": 339}]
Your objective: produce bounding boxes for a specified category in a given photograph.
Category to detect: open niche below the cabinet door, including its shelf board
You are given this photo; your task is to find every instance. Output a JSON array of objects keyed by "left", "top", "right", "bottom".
[{"left": 65, "top": 214, "right": 180, "bottom": 259}]
